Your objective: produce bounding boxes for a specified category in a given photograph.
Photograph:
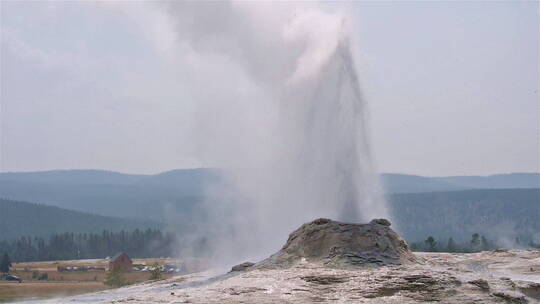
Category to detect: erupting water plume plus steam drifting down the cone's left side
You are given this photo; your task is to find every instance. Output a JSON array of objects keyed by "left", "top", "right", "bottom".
[{"left": 221, "top": 36, "right": 388, "bottom": 258}]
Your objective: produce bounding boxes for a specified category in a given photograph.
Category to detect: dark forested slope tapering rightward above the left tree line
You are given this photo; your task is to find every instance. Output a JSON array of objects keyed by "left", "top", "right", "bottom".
[{"left": 0, "top": 199, "right": 160, "bottom": 240}]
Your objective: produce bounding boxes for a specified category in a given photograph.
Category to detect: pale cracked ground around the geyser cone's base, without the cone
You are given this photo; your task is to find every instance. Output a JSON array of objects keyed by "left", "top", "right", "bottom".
[{"left": 23, "top": 250, "right": 540, "bottom": 304}]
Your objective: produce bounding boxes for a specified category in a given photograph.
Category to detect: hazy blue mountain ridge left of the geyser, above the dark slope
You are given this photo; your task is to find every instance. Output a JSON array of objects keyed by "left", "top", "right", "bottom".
[{"left": 0, "top": 169, "right": 219, "bottom": 221}]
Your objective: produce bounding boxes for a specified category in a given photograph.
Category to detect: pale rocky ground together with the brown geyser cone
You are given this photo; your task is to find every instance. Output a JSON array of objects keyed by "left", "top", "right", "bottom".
[{"left": 20, "top": 219, "right": 540, "bottom": 304}]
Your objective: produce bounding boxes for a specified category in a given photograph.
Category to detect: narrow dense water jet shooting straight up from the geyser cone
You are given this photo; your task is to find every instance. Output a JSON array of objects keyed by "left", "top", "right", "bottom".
[{"left": 282, "top": 41, "right": 388, "bottom": 222}]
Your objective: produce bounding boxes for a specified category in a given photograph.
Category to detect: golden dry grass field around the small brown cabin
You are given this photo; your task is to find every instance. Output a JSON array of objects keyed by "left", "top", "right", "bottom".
[{"left": 0, "top": 258, "right": 186, "bottom": 302}]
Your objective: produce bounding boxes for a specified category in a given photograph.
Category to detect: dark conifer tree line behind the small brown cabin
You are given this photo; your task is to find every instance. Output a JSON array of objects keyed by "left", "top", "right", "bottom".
[{"left": 0, "top": 228, "right": 178, "bottom": 262}]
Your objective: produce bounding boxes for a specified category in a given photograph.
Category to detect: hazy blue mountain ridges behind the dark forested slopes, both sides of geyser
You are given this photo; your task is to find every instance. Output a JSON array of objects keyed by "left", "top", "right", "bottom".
[{"left": 0, "top": 168, "right": 540, "bottom": 222}]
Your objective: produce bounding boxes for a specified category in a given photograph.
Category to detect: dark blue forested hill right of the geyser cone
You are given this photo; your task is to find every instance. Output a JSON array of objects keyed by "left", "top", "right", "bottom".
[{"left": 388, "top": 189, "right": 540, "bottom": 244}]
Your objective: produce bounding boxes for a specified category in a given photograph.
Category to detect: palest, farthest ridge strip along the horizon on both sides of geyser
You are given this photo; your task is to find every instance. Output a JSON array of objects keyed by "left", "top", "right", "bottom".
[{"left": 0, "top": 168, "right": 540, "bottom": 199}]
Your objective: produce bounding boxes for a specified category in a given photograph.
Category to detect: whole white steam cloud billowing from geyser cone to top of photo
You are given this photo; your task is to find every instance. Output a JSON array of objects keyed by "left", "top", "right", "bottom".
[{"left": 160, "top": 1, "right": 388, "bottom": 260}]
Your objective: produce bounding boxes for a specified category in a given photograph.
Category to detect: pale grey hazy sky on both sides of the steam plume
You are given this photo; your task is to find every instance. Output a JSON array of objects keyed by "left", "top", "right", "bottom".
[{"left": 0, "top": 1, "right": 540, "bottom": 175}]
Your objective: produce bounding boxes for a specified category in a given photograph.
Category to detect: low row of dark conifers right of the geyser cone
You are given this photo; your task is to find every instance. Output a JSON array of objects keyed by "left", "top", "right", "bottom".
[{"left": 410, "top": 233, "right": 540, "bottom": 253}]
